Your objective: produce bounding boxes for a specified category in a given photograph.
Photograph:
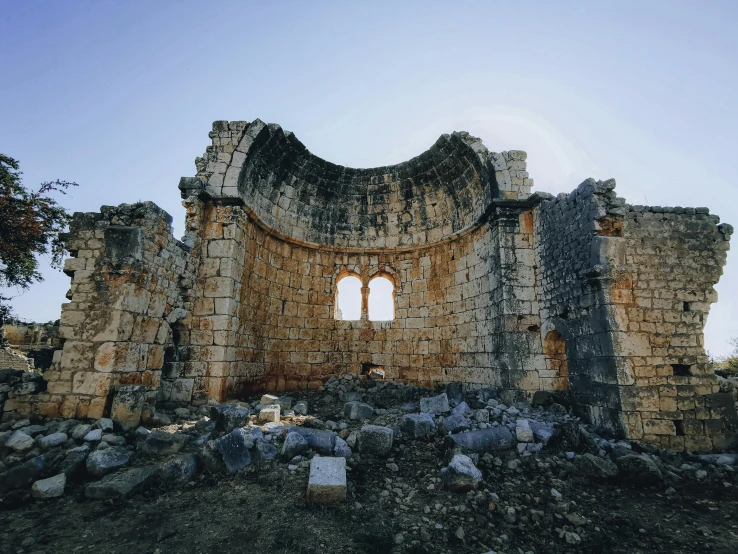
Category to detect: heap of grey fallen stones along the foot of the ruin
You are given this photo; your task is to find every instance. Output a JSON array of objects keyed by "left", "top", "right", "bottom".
[{"left": 0, "top": 375, "right": 738, "bottom": 552}]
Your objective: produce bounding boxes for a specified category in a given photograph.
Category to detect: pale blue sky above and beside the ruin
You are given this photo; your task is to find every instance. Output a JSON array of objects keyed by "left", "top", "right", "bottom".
[{"left": 0, "top": 0, "right": 738, "bottom": 354}]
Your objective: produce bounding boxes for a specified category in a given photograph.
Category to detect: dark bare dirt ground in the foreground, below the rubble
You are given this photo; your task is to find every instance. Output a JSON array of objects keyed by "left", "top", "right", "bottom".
[{"left": 0, "top": 388, "right": 738, "bottom": 554}]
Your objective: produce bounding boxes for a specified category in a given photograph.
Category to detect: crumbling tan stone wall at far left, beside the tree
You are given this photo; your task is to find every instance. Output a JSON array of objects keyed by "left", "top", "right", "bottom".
[{"left": 5, "top": 202, "right": 192, "bottom": 418}]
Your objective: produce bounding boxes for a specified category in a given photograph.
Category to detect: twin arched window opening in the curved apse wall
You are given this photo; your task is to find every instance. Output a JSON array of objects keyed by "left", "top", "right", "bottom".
[{"left": 335, "top": 274, "right": 395, "bottom": 321}]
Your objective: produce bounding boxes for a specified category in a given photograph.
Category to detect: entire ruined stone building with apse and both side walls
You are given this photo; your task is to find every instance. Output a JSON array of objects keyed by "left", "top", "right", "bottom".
[{"left": 5, "top": 120, "right": 735, "bottom": 450}]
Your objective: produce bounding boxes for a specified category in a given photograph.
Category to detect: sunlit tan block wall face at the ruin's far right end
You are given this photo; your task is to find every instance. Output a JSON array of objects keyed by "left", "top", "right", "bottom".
[{"left": 614, "top": 206, "right": 738, "bottom": 450}]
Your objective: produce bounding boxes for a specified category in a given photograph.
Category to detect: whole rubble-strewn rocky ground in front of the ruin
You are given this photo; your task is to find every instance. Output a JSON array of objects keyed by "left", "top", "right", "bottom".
[{"left": 0, "top": 377, "right": 738, "bottom": 554}]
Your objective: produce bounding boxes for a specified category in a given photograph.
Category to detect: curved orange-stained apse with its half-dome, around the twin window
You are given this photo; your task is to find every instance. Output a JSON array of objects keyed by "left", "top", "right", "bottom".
[{"left": 180, "top": 120, "right": 533, "bottom": 396}]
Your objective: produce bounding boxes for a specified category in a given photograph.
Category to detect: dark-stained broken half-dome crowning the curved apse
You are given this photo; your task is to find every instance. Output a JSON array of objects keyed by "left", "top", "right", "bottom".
[{"left": 193, "top": 120, "right": 496, "bottom": 250}]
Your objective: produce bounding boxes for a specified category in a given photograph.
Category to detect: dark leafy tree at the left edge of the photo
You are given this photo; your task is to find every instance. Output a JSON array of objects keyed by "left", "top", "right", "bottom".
[{"left": 0, "top": 154, "right": 77, "bottom": 326}]
